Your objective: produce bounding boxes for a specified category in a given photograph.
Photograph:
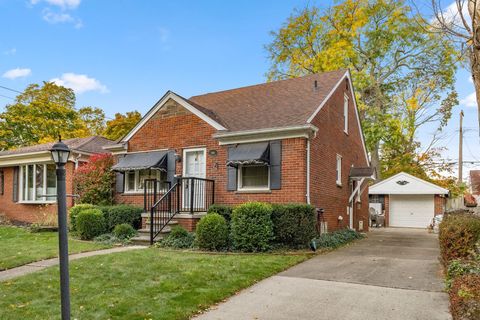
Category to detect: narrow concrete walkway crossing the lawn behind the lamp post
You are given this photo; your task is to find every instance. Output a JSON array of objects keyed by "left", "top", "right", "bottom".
[{"left": 0, "top": 246, "right": 147, "bottom": 282}]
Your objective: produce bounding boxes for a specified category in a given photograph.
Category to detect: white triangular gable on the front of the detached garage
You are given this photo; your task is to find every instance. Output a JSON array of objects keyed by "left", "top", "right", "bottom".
[{"left": 369, "top": 172, "right": 448, "bottom": 194}]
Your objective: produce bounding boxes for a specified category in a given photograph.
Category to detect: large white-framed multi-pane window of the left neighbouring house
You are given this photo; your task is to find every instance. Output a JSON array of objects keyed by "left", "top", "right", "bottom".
[{"left": 20, "top": 163, "right": 57, "bottom": 203}]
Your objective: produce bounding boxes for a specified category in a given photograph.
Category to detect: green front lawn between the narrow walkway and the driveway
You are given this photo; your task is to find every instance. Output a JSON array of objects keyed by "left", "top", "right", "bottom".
[{"left": 0, "top": 248, "right": 310, "bottom": 320}]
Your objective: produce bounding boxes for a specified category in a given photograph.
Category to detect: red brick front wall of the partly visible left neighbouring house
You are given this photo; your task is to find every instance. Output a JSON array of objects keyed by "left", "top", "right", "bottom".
[{"left": 0, "top": 162, "right": 75, "bottom": 224}]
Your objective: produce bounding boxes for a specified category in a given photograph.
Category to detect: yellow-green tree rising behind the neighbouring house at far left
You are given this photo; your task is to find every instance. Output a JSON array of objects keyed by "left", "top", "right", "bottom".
[{"left": 0, "top": 82, "right": 88, "bottom": 149}]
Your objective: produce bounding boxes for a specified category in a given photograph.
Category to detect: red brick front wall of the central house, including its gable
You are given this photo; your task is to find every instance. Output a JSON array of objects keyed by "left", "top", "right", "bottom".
[{"left": 116, "top": 100, "right": 306, "bottom": 206}]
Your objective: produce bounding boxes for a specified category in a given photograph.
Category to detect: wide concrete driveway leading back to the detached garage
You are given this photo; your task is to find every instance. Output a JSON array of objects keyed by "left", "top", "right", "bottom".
[{"left": 197, "top": 228, "right": 451, "bottom": 320}]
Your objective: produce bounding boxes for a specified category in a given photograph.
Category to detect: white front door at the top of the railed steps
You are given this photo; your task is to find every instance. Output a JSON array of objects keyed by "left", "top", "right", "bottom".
[{"left": 183, "top": 148, "right": 207, "bottom": 211}]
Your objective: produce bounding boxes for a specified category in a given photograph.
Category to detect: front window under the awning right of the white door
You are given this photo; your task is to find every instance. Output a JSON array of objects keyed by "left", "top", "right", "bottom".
[{"left": 238, "top": 165, "right": 270, "bottom": 190}]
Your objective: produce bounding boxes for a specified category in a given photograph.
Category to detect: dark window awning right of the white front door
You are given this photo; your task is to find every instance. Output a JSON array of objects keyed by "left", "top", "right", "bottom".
[{"left": 227, "top": 142, "right": 270, "bottom": 167}]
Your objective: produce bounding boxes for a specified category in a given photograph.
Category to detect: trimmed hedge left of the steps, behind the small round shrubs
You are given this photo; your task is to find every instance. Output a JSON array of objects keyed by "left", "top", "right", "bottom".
[{"left": 100, "top": 204, "right": 143, "bottom": 231}]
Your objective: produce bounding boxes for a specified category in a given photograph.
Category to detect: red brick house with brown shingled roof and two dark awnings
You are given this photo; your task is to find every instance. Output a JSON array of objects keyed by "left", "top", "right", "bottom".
[{"left": 105, "top": 70, "right": 372, "bottom": 238}]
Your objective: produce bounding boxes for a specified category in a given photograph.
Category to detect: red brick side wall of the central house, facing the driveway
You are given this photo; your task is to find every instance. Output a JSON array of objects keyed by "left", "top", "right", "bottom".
[{"left": 310, "top": 81, "right": 368, "bottom": 230}]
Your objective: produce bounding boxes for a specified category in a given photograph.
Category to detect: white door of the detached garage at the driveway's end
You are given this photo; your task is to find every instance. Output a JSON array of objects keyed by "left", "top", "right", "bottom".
[{"left": 390, "top": 195, "right": 435, "bottom": 228}]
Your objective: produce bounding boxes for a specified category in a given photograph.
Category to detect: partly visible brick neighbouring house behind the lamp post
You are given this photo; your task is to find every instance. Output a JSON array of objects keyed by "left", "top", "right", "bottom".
[{"left": 0, "top": 136, "right": 113, "bottom": 223}]
